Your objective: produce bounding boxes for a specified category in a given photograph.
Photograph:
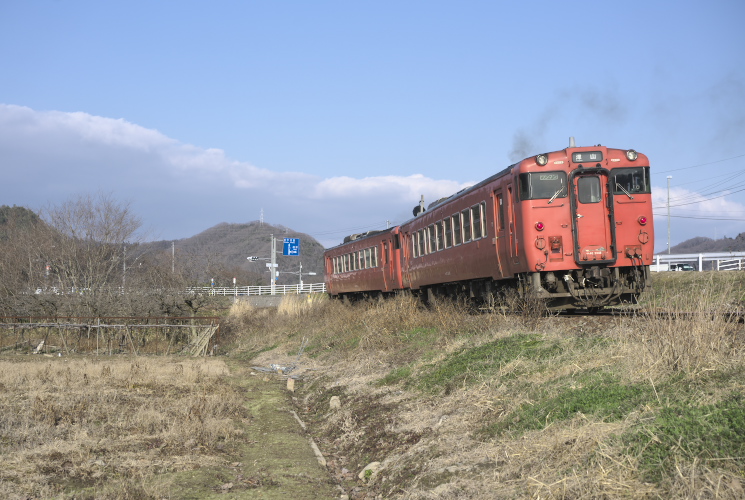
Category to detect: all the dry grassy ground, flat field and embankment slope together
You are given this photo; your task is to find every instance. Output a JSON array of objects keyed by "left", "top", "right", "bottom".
[{"left": 0, "top": 273, "right": 745, "bottom": 499}]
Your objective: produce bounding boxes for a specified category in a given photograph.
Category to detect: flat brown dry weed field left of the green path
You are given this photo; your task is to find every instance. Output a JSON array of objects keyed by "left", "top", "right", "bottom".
[{"left": 0, "top": 357, "right": 248, "bottom": 498}]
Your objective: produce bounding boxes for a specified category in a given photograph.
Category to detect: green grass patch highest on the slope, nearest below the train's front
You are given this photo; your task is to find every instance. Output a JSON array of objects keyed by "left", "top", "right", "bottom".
[{"left": 417, "top": 334, "right": 563, "bottom": 393}]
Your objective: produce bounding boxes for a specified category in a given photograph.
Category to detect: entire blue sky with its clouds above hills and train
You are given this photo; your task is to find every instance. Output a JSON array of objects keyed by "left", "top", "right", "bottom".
[{"left": 0, "top": 0, "right": 745, "bottom": 250}]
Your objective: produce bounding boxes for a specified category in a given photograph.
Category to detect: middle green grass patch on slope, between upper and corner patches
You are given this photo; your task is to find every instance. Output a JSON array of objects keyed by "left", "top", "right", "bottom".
[{"left": 478, "top": 371, "right": 656, "bottom": 437}]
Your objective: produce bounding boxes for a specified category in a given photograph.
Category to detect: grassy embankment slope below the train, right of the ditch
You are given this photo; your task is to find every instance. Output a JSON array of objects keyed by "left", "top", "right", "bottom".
[{"left": 228, "top": 273, "right": 745, "bottom": 498}]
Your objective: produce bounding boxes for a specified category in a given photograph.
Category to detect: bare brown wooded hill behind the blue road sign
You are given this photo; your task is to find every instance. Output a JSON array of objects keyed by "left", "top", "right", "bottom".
[{"left": 138, "top": 221, "right": 324, "bottom": 286}]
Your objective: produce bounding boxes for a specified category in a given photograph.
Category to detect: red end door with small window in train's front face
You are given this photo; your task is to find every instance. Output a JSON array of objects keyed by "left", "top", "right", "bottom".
[{"left": 569, "top": 168, "right": 616, "bottom": 265}]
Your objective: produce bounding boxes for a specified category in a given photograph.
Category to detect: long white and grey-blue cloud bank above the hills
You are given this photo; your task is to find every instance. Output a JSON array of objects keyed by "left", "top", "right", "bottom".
[{"left": 0, "top": 104, "right": 467, "bottom": 244}]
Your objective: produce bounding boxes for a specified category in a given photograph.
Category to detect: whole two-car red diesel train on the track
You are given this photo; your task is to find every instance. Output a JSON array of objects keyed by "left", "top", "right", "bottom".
[{"left": 325, "top": 145, "right": 654, "bottom": 309}]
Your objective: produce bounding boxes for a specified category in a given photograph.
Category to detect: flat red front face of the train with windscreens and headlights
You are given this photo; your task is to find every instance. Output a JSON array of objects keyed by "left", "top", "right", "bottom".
[{"left": 513, "top": 146, "right": 654, "bottom": 309}]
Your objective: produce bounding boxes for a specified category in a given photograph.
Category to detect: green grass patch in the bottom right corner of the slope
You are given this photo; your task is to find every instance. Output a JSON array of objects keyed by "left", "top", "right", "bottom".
[{"left": 621, "top": 394, "right": 745, "bottom": 483}]
